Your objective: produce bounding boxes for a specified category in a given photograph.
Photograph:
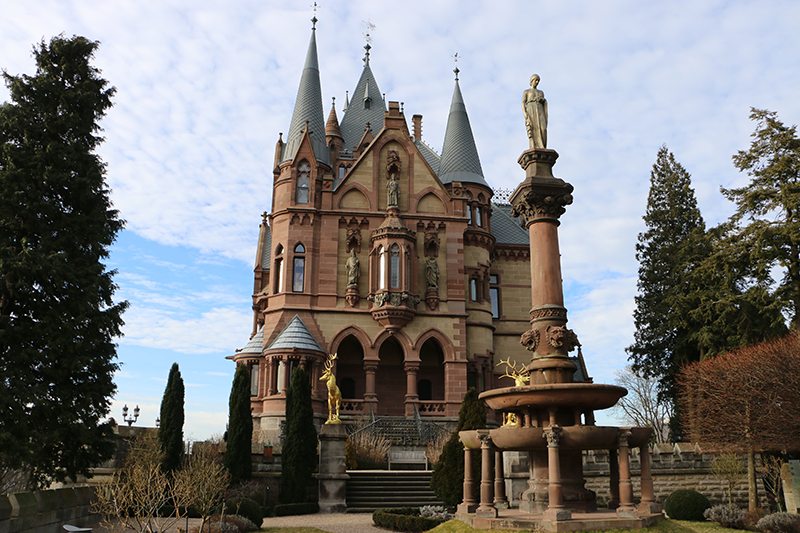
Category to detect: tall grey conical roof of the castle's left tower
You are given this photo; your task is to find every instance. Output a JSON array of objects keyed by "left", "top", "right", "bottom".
[{"left": 282, "top": 20, "right": 330, "bottom": 163}]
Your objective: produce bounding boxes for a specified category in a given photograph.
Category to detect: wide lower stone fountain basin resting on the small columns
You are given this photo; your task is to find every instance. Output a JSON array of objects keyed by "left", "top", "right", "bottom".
[{"left": 458, "top": 426, "right": 653, "bottom": 451}]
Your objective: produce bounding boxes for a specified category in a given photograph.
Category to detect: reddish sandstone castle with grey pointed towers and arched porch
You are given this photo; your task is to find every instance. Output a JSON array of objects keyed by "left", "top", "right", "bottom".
[{"left": 229, "top": 18, "right": 586, "bottom": 437}]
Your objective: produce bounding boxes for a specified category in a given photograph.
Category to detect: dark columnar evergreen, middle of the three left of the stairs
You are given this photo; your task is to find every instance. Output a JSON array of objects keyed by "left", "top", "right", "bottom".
[{"left": 225, "top": 364, "right": 253, "bottom": 484}]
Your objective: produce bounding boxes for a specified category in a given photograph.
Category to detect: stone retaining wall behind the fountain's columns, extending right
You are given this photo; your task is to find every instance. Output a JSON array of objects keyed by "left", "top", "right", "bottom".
[{"left": 505, "top": 443, "right": 767, "bottom": 509}]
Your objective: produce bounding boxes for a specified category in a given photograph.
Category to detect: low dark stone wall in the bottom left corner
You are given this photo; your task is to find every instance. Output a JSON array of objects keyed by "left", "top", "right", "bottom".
[{"left": 0, "top": 487, "right": 100, "bottom": 533}]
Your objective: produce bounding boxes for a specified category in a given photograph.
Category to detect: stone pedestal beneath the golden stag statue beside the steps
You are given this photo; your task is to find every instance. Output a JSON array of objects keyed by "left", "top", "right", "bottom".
[{"left": 318, "top": 424, "right": 350, "bottom": 513}]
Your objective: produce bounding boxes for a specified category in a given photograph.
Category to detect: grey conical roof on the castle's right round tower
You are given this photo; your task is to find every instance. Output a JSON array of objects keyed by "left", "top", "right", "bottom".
[{"left": 439, "top": 77, "right": 489, "bottom": 187}]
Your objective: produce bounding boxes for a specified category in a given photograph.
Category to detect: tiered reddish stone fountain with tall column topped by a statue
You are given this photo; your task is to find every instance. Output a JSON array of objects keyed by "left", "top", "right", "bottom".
[{"left": 458, "top": 75, "right": 661, "bottom": 531}]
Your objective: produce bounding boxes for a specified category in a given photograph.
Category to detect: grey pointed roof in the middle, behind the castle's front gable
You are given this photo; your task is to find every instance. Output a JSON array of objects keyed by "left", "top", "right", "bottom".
[{"left": 339, "top": 44, "right": 386, "bottom": 150}]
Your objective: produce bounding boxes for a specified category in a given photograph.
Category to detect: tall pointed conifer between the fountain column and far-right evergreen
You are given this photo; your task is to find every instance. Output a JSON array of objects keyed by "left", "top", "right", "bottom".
[{"left": 627, "top": 146, "right": 708, "bottom": 404}]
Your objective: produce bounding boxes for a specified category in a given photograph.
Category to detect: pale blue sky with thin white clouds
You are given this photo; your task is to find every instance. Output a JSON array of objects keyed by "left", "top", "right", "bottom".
[{"left": 0, "top": 0, "right": 800, "bottom": 440}]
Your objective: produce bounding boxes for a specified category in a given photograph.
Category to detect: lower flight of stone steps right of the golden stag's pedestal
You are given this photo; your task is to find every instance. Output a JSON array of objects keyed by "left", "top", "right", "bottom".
[{"left": 347, "top": 470, "right": 443, "bottom": 513}]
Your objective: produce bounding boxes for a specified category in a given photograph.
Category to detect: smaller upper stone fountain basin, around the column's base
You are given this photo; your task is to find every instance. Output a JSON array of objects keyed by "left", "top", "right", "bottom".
[{"left": 479, "top": 383, "right": 628, "bottom": 411}]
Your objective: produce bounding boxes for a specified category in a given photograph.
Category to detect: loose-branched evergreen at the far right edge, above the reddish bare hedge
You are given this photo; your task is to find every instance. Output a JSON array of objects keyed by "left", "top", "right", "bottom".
[{"left": 722, "top": 109, "right": 800, "bottom": 330}]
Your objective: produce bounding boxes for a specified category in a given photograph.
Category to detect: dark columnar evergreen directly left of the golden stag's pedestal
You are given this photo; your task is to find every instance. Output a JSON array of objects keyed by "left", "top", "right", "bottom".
[{"left": 279, "top": 367, "right": 319, "bottom": 503}]
